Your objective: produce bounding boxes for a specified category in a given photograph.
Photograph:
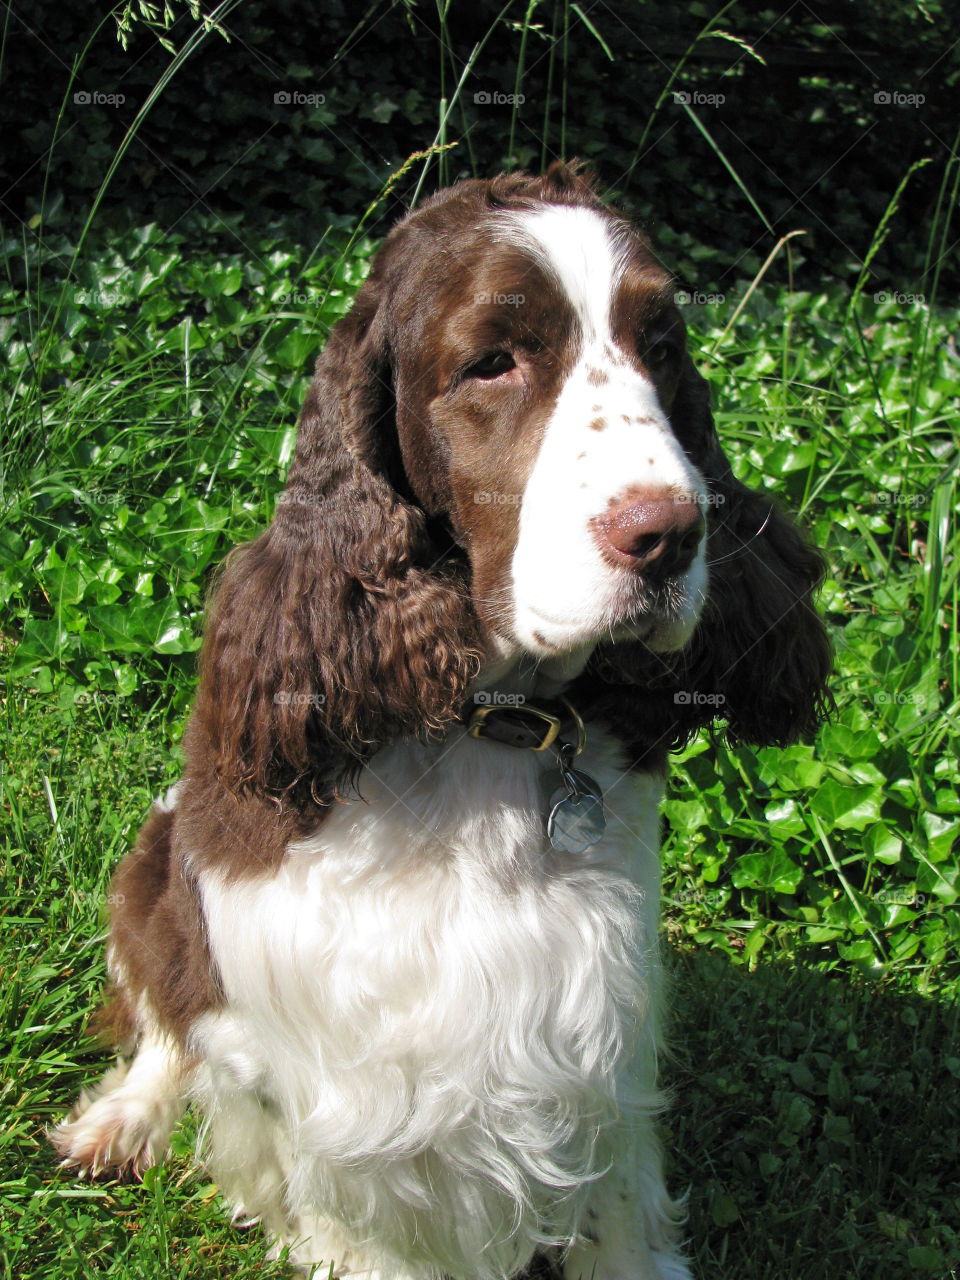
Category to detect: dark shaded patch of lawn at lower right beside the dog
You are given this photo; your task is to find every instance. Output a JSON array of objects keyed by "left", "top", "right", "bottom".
[{"left": 671, "top": 948, "right": 960, "bottom": 1280}]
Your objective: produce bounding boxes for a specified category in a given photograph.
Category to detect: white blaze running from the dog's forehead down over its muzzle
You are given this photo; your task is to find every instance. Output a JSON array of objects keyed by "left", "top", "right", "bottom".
[{"left": 497, "top": 205, "right": 707, "bottom": 657}]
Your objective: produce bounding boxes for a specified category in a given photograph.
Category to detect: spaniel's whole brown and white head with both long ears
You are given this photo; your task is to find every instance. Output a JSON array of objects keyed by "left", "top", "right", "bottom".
[{"left": 198, "top": 165, "right": 828, "bottom": 791}]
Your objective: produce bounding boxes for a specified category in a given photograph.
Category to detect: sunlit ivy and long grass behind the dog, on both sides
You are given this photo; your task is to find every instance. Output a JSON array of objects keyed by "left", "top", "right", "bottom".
[{"left": 0, "top": 221, "right": 960, "bottom": 986}]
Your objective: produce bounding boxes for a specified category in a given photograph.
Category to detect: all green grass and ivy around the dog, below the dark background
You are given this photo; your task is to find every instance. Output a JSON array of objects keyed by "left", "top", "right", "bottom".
[{"left": 0, "top": 10, "right": 960, "bottom": 1280}]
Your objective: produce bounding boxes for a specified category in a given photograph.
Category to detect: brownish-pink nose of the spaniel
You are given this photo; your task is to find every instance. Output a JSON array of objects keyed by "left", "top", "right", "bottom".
[{"left": 595, "top": 492, "right": 707, "bottom": 582}]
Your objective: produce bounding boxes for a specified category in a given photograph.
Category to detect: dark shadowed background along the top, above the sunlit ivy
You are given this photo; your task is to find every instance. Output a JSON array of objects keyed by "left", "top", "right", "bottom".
[{"left": 0, "top": 0, "right": 960, "bottom": 294}]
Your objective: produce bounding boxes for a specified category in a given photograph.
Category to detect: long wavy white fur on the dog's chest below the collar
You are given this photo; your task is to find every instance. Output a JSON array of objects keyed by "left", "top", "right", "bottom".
[{"left": 196, "top": 732, "right": 660, "bottom": 1274}]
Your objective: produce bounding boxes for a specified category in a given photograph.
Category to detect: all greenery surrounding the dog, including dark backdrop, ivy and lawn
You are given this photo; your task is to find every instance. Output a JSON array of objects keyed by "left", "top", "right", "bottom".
[{"left": 0, "top": 0, "right": 960, "bottom": 1280}]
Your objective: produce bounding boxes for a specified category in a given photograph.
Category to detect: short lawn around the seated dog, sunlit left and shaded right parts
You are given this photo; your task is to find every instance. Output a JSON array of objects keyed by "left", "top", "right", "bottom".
[{"left": 7, "top": 691, "right": 960, "bottom": 1280}]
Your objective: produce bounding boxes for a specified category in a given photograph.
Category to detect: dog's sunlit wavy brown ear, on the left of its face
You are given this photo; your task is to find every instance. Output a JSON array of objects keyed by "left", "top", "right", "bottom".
[{"left": 197, "top": 251, "right": 480, "bottom": 796}]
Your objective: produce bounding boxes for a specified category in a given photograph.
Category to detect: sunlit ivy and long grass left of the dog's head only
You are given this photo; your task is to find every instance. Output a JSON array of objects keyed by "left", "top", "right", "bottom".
[{"left": 0, "top": 213, "right": 370, "bottom": 696}]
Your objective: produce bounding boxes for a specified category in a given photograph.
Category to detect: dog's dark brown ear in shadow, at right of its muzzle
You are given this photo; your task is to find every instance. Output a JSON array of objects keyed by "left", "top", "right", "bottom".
[{"left": 586, "top": 357, "right": 832, "bottom": 748}]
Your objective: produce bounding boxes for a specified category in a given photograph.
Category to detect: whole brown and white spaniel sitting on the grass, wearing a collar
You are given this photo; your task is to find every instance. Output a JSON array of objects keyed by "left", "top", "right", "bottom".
[{"left": 52, "top": 165, "right": 829, "bottom": 1280}]
